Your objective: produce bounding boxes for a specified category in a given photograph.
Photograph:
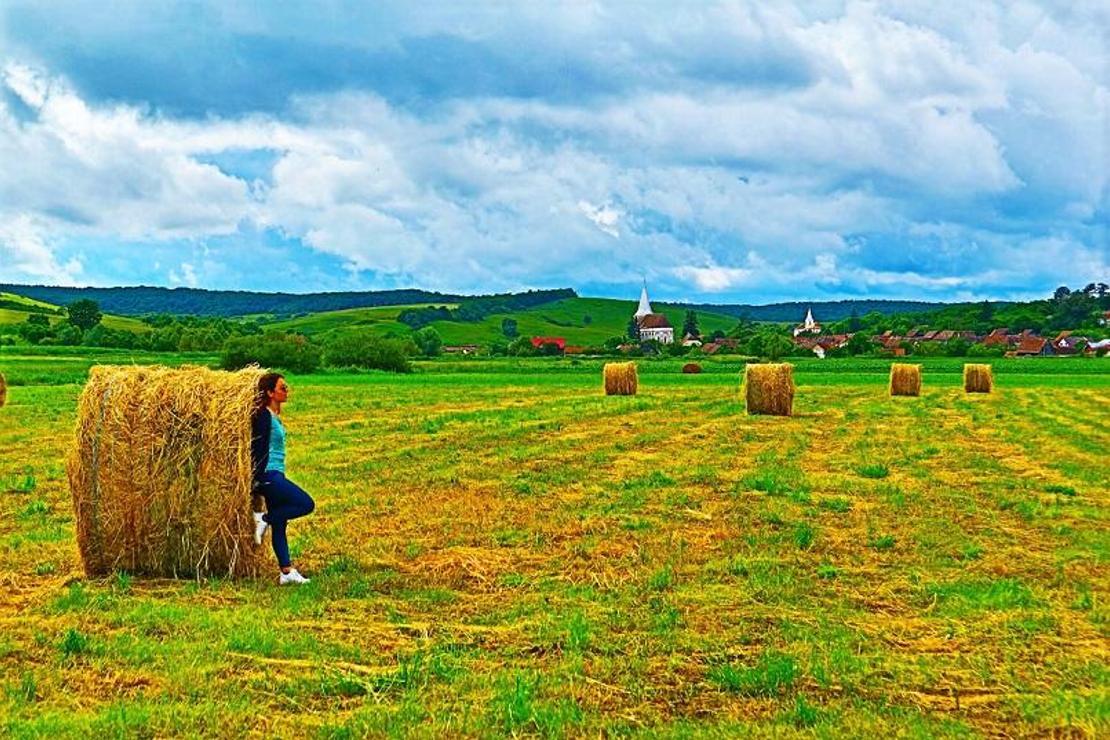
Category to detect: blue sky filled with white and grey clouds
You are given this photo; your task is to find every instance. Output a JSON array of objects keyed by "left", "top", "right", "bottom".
[{"left": 0, "top": 0, "right": 1110, "bottom": 303}]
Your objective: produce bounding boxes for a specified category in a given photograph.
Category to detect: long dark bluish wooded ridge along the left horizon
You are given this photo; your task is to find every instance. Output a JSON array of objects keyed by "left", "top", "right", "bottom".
[{"left": 0, "top": 284, "right": 464, "bottom": 316}]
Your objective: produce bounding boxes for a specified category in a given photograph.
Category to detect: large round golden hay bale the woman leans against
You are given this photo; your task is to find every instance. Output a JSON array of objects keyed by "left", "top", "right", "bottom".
[{"left": 67, "top": 366, "right": 265, "bottom": 578}]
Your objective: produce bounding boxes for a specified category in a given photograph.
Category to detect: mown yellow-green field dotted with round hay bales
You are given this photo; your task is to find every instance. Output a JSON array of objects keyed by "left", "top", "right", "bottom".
[{"left": 0, "top": 347, "right": 1110, "bottom": 737}]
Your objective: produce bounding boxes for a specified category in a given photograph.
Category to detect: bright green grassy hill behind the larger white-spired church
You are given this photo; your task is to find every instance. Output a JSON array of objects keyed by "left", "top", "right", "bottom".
[{"left": 266, "top": 298, "right": 736, "bottom": 345}]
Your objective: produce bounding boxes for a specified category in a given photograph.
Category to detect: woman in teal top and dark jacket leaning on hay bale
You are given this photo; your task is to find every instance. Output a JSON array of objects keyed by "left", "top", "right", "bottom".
[{"left": 251, "top": 373, "right": 316, "bottom": 586}]
